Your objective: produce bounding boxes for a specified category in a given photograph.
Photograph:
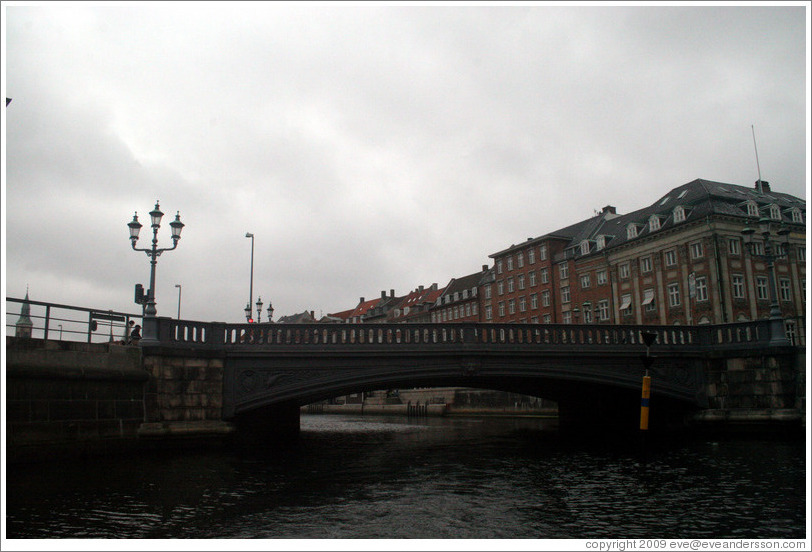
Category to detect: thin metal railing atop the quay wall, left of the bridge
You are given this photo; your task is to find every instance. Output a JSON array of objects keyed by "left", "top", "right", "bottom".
[{"left": 6, "top": 297, "right": 142, "bottom": 343}]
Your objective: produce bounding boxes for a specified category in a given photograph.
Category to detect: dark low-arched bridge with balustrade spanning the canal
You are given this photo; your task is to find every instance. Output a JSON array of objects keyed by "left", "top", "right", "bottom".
[{"left": 144, "top": 318, "right": 797, "bottom": 438}]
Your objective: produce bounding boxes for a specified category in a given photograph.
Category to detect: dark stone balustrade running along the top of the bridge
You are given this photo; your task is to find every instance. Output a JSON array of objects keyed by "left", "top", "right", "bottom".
[{"left": 159, "top": 318, "right": 788, "bottom": 350}]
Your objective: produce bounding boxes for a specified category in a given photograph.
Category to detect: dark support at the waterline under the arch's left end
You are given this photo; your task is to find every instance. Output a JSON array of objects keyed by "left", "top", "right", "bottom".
[{"left": 233, "top": 405, "right": 300, "bottom": 449}]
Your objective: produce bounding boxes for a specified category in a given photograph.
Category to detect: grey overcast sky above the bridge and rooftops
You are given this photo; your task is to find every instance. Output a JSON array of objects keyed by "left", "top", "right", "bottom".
[{"left": 2, "top": 2, "right": 809, "bottom": 322}]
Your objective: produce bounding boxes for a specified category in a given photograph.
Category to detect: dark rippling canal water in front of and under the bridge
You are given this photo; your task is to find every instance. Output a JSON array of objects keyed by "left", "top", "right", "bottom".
[{"left": 5, "top": 415, "right": 808, "bottom": 549}]
